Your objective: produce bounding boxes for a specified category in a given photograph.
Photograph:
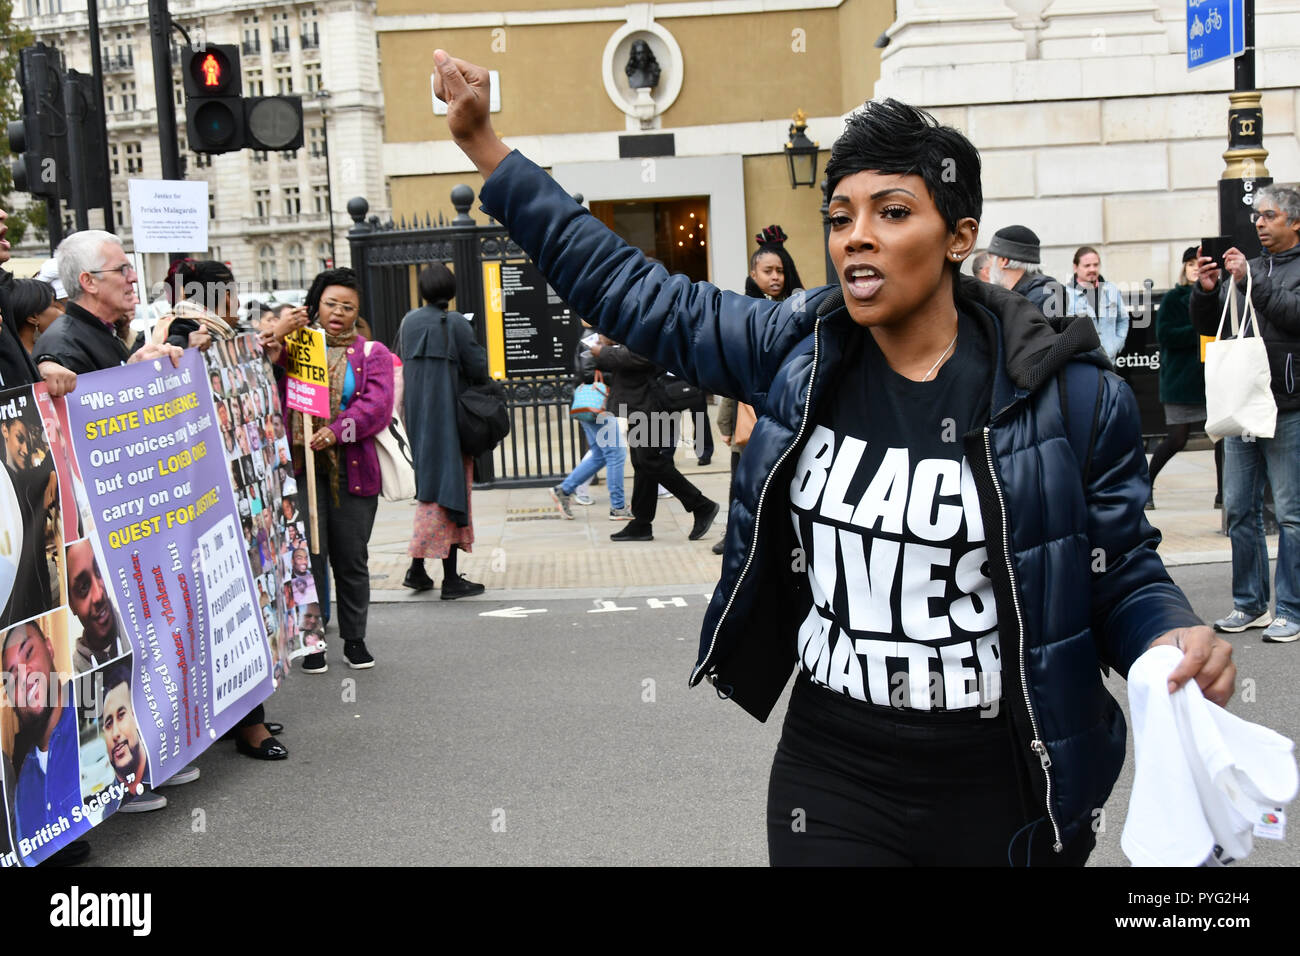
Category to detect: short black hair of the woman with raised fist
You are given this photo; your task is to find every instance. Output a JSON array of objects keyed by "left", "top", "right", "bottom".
[{"left": 826, "top": 99, "right": 984, "bottom": 236}]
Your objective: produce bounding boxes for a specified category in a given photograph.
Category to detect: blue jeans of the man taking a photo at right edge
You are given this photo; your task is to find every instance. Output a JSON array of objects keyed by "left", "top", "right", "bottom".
[{"left": 1223, "top": 411, "right": 1300, "bottom": 620}]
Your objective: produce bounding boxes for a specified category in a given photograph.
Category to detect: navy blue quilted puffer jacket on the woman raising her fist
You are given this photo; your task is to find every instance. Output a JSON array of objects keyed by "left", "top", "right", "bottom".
[{"left": 481, "top": 152, "right": 1201, "bottom": 849}]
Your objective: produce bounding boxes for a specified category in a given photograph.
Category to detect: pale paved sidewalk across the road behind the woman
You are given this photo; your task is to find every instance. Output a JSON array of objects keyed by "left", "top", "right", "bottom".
[{"left": 371, "top": 441, "right": 1258, "bottom": 601}]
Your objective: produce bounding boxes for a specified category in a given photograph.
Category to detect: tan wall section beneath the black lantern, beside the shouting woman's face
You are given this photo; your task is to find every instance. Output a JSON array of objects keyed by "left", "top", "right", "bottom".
[{"left": 736, "top": 151, "right": 829, "bottom": 291}]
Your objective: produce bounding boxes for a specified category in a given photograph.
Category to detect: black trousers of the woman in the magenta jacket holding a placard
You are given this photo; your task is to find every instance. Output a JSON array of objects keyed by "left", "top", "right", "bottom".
[{"left": 298, "top": 470, "right": 380, "bottom": 643}]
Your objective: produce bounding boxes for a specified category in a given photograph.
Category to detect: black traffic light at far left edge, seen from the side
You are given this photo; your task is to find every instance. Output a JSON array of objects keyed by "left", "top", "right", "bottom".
[{"left": 7, "top": 43, "right": 69, "bottom": 199}]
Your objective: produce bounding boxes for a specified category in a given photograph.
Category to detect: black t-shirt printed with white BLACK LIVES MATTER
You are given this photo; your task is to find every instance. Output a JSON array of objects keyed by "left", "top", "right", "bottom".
[{"left": 790, "top": 313, "right": 1001, "bottom": 710}]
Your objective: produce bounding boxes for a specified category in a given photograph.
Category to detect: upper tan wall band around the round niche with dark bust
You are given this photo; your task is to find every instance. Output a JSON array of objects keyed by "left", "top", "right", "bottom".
[{"left": 380, "top": 8, "right": 852, "bottom": 143}]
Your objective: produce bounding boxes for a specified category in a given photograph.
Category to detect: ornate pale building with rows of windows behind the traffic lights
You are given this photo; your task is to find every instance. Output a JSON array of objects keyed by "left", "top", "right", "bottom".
[{"left": 14, "top": 0, "right": 387, "bottom": 289}]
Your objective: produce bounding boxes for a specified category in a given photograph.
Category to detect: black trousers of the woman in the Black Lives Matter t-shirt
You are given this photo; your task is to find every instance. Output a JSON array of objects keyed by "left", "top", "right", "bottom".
[{"left": 767, "top": 674, "right": 1096, "bottom": 866}]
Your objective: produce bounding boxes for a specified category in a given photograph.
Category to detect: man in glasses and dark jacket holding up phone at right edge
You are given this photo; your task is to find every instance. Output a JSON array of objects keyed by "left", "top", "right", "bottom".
[{"left": 1191, "top": 185, "right": 1300, "bottom": 643}]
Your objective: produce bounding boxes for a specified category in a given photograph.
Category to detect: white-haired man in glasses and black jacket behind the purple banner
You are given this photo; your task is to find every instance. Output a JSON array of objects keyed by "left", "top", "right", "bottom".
[{"left": 35, "top": 229, "right": 181, "bottom": 375}]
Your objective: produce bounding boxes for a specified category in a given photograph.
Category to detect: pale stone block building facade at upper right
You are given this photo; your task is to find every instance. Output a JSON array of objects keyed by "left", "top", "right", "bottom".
[{"left": 876, "top": 0, "right": 1300, "bottom": 289}]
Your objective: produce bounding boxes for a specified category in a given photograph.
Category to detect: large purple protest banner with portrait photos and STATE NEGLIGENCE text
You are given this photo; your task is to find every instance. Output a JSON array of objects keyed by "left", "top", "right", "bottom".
[{"left": 0, "top": 336, "right": 299, "bottom": 866}]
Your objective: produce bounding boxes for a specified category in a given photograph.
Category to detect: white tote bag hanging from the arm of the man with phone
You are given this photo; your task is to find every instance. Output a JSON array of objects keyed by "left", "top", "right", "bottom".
[{"left": 1205, "top": 271, "right": 1278, "bottom": 441}]
